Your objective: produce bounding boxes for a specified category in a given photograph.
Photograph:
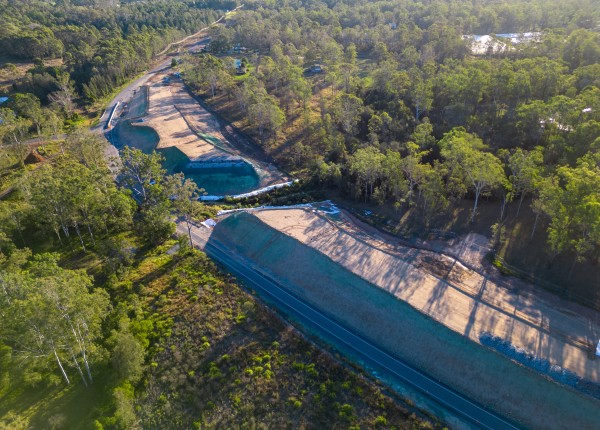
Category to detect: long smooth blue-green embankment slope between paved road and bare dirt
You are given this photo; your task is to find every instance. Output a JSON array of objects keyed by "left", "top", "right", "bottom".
[{"left": 211, "top": 213, "right": 600, "bottom": 429}]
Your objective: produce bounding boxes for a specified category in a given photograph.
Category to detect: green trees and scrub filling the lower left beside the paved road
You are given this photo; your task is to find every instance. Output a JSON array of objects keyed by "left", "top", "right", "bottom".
[{"left": 0, "top": 131, "right": 440, "bottom": 430}]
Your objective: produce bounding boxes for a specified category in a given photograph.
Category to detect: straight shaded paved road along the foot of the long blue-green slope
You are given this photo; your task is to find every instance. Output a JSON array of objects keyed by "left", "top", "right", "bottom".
[{"left": 204, "top": 238, "right": 519, "bottom": 430}]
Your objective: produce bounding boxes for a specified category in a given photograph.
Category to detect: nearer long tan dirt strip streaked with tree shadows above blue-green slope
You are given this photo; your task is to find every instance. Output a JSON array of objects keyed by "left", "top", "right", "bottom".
[{"left": 255, "top": 209, "right": 600, "bottom": 382}]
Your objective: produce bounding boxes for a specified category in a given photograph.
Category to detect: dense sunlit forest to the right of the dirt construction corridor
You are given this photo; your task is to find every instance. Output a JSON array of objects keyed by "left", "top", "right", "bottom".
[{"left": 182, "top": 1, "right": 600, "bottom": 301}]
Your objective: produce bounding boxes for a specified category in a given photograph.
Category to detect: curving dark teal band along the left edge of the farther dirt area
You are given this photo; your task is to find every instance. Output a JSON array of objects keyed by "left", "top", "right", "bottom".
[{"left": 112, "top": 89, "right": 260, "bottom": 196}]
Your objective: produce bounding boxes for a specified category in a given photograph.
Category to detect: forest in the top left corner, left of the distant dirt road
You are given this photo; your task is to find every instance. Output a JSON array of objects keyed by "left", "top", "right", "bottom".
[{"left": 0, "top": 0, "right": 237, "bottom": 168}]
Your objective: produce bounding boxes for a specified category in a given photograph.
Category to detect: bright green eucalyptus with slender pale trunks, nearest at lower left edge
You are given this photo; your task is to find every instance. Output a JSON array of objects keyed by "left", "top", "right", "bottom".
[{"left": 0, "top": 254, "right": 110, "bottom": 385}]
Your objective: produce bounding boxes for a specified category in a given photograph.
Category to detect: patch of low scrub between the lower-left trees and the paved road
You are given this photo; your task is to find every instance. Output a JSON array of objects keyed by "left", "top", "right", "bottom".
[{"left": 133, "top": 244, "right": 438, "bottom": 428}]
